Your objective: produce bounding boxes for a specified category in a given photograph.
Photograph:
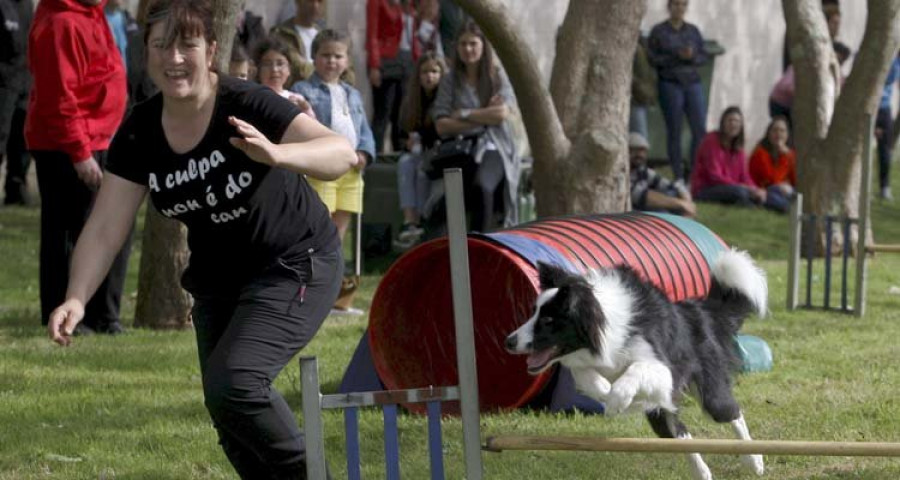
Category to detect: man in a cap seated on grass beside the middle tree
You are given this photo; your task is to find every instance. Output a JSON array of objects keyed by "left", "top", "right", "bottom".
[{"left": 628, "top": 132, "right": 697, "bottom": 217}]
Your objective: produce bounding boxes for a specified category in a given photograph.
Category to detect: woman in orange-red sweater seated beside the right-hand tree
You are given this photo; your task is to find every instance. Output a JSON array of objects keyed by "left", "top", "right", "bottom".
[{"left": 750, "top": 116, "right": 797, "bottom": 211}]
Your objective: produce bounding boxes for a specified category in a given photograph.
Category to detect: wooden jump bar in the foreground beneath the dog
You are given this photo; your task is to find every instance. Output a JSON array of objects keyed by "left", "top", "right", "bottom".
[{"left": 484, "top": 436, "right": 900, "bottom": 457}]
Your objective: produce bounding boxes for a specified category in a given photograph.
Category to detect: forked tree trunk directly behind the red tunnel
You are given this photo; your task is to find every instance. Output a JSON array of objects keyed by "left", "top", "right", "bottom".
[{"left": 457, "top": 0, "right": 646, "bottom": 216}]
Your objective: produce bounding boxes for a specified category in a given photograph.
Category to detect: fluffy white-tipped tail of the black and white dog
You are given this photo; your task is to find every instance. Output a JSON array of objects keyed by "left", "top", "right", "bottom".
[{"left": 704, "top": 249, "right": 769, "bottom": 335}]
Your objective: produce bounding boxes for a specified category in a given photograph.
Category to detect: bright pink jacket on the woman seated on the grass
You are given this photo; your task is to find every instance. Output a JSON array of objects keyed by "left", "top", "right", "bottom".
[{"left": 691, "top": 131, "right": 756, "bottom": 196}]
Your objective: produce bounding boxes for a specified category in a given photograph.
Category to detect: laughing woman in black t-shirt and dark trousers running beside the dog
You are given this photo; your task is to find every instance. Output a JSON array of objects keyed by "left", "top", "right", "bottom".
[{"left": 48, "top": 0, "right": 356, "bottom": 479}]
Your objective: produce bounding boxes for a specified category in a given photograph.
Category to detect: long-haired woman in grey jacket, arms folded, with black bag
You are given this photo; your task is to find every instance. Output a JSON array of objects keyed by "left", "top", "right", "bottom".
[{"left": 429, "top": 20, "right": 521, "bottom": 232}]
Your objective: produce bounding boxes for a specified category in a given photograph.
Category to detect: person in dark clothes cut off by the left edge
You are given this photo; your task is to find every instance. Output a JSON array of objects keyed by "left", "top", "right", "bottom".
[{"left": 0, "top": 0, "right": 34, "bottom": 205}]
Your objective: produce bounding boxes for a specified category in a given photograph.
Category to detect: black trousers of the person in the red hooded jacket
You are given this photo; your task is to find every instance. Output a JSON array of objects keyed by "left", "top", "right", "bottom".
[{"left": 31, "top": 151, "right": 131, "bottom": 331}]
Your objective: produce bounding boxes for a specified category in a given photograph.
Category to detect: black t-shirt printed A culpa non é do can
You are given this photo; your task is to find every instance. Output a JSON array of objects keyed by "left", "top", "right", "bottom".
[{"left": 106, "top": 76, "right": 340, "bottom": 294}]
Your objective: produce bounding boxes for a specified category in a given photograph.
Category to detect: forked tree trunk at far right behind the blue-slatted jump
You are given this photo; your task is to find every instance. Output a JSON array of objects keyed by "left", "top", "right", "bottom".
[{"left": 783, "top": 0, "right": 900, "bottom": 253}]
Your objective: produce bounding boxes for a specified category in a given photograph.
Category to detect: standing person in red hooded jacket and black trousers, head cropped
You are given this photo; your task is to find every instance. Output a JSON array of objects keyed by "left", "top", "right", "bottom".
[{"left": 25, "top": 0, "right": 130, "bottom": 334}]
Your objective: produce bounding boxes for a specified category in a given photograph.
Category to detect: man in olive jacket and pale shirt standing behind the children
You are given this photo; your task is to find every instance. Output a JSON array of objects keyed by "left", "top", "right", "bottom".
[{"left": 269, "top": 0, "right": 325, "bottom": 84}]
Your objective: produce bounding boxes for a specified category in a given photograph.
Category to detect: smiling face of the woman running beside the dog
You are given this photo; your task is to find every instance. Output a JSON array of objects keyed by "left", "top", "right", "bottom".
[{"left": 147, "top": 22, "right": 216, "bottom": 99}]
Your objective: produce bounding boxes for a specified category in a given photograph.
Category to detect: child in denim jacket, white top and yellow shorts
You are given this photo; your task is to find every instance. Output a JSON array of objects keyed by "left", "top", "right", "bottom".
[{"left": 291, "top": 29, "right": 375, "bottom": 313}]
